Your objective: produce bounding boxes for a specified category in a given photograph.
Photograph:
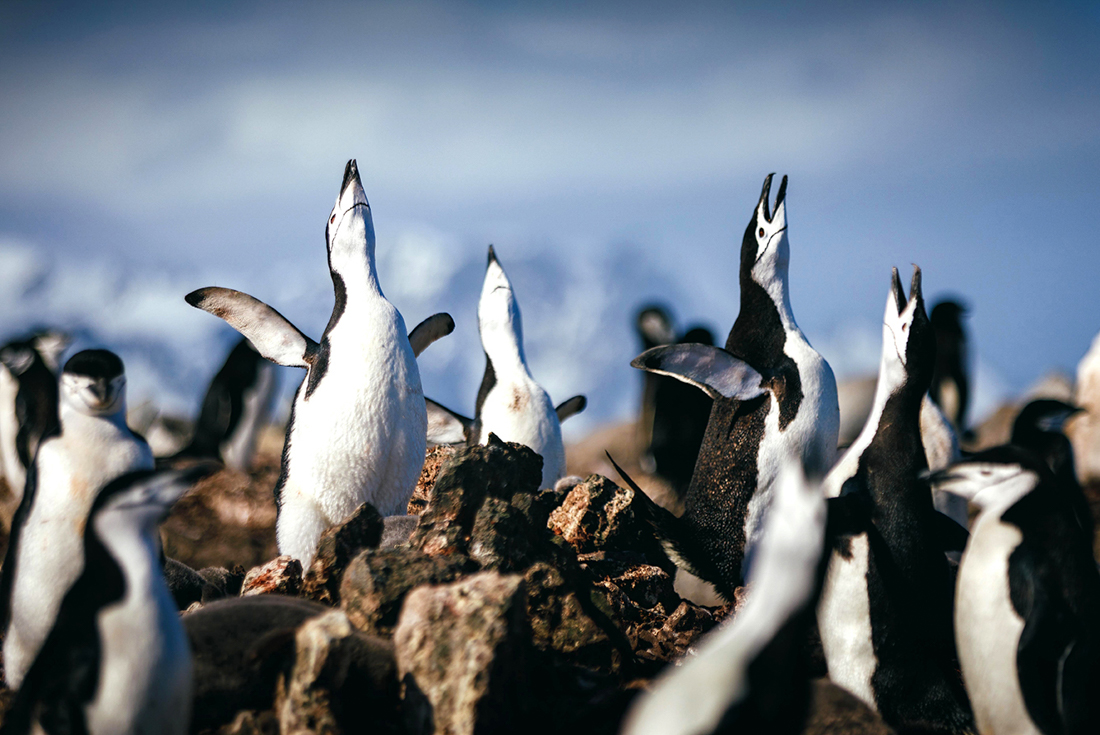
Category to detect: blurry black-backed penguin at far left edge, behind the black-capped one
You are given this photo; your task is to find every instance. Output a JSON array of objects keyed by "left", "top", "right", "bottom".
[{"left": 0, "top": 337, "right": 57, "bottom": 502}]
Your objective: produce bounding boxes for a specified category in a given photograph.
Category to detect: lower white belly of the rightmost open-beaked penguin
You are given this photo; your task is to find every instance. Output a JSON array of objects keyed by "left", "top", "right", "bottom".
[{"left": 817, "top": 534, "right": 878, "bottom": 712}]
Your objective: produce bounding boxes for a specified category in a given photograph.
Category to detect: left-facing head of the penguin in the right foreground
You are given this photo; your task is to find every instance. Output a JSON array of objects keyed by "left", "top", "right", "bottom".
[{"left": 928, "top": 445, "right": 1051, "bottom": 511}]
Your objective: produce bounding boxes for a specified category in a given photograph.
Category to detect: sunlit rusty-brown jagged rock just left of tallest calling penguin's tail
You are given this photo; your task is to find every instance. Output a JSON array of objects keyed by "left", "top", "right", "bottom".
[{"left": 547, "top": 474, "right": 671, "bottom": 572}]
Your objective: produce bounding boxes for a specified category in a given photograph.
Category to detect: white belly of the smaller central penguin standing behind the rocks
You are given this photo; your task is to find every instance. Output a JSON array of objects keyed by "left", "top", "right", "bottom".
[{"left": 477, "top": 381, "right": 565, "bottom": 487}]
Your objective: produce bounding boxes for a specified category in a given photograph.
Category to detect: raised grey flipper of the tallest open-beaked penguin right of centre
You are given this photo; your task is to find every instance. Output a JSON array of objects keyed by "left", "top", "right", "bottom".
[{"left": 630, "top": 342, "right": 765, "bottom": 401}]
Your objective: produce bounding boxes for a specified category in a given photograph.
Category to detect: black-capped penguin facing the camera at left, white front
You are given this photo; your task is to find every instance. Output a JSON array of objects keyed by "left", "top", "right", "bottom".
[{"left": 0, "top": 350, "right": 153, "bottom": 688}]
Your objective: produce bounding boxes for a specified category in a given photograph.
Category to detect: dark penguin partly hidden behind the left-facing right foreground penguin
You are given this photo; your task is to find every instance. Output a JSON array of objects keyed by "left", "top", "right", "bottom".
[{"left": 1011, "top": 398, "right": 1096, "bottom": 539}]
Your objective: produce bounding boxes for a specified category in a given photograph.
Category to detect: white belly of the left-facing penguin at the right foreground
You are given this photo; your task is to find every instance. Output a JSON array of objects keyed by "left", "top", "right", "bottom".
[{"left": 955, "top": 517, "right": 1040, "bottom": 735}]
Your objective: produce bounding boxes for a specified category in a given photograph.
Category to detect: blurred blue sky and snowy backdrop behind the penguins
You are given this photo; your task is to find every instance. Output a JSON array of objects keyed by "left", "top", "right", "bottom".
[{"left": 0, "top": 2, "right": 1100, "bottom": 428}]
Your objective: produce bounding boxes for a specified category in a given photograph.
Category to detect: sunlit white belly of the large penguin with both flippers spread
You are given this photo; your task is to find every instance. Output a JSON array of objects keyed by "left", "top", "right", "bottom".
[{"left": 276, "top": 317, "right": 428, "bottom": 558}]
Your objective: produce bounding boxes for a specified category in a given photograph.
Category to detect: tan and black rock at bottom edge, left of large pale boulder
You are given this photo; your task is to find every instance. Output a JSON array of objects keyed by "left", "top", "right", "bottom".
[{"left": 275, "top": 610, "right": 398, "bottom": 735}]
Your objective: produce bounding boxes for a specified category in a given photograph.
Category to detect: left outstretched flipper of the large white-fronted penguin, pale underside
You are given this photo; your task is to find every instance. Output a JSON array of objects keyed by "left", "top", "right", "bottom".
[{"left": 185, "top": 286, "right": 318, "bottom": 368}]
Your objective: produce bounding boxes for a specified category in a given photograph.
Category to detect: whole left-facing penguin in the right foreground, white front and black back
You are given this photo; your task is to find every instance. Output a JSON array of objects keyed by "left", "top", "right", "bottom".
[{"left": 931, "top": 445, "right": 1100, "bottom": 735}]
